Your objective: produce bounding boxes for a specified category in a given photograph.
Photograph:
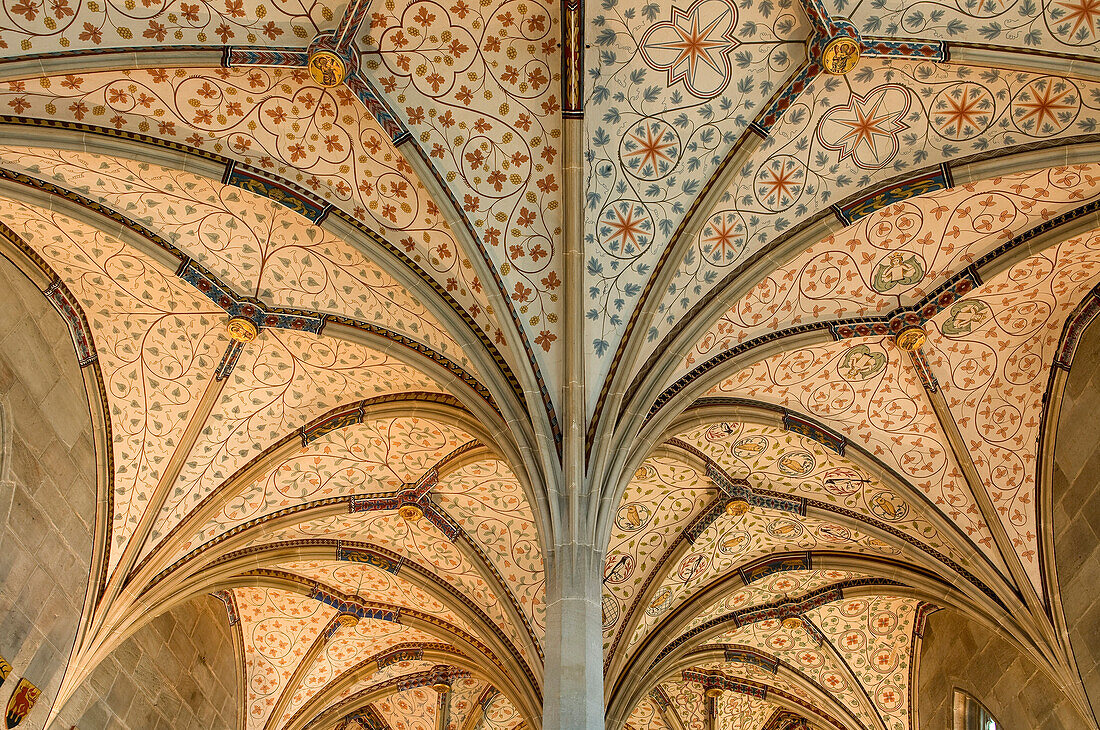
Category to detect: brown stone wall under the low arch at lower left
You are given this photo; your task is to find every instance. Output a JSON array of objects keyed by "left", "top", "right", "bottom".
[{"left": 51, "top": 596, "right": 244, "bottom": 730}]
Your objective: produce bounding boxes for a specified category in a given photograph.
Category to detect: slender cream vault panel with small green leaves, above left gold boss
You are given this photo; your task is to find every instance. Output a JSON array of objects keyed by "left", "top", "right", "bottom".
[{"left": 0, "top": 147, "right": 472, "bottom": 369}]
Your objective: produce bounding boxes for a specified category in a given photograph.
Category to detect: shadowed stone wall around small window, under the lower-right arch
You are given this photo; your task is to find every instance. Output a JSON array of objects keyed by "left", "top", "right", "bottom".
[{"left": 916, "top": 609, "right": 1092, "bottom": 730}]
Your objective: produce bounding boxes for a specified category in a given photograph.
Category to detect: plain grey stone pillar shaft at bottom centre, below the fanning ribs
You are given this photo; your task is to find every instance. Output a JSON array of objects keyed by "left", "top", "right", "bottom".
[{"left": 542, "top": 543, "right": 604, "bottom": 730}]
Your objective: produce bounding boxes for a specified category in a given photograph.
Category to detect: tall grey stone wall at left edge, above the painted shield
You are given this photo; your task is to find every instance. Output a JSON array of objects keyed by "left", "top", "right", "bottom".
[{"left": 0, "top": 257, "right": 96, "bottom": 730}]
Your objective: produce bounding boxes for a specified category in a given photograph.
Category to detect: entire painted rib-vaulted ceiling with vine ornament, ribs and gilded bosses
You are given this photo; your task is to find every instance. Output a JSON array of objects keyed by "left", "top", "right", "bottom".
[{"left": 0, "top": 0, "right": 1100, "bottom": 730}]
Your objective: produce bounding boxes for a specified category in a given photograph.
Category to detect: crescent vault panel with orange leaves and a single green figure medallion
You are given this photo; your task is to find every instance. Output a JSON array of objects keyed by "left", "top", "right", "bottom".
[{"left": 674, "top": 165, "right": 1100, "bottom": 378}]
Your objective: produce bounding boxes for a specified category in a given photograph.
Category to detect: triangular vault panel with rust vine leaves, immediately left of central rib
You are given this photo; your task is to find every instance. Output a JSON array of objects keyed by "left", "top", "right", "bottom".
[{"left": 360, "top": 0, "right": 562, "bottom": 386}]
